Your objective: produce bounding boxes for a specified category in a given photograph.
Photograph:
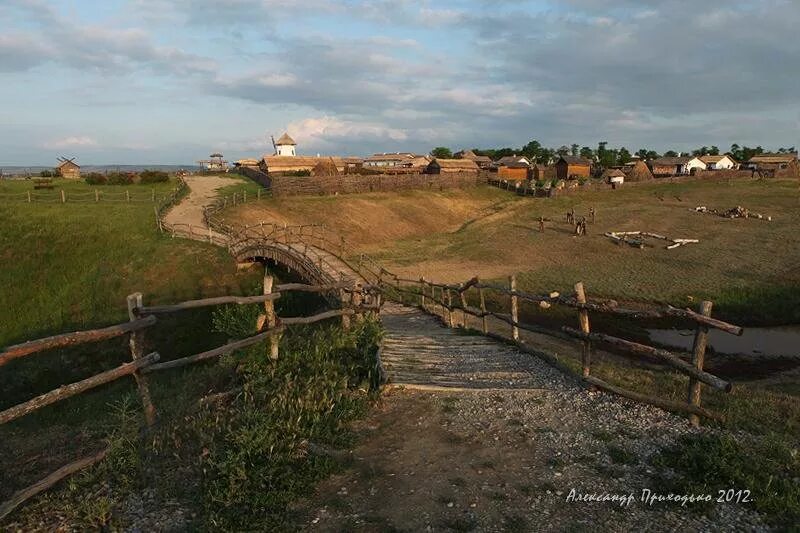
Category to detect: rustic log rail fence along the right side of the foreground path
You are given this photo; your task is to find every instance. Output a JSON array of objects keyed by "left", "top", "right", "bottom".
[{"left": 384, "top": 276, "right": 743, "bottom": 426}]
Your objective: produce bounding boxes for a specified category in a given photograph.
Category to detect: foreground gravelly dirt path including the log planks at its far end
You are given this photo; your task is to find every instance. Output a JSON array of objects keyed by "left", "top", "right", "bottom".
[{"left": 295, "top": 304, "right": 765, "bottom": 532}]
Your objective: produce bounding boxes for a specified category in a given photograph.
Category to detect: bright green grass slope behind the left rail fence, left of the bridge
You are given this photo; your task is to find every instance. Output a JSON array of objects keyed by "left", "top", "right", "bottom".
[{"left": 0, "top": 182, "right": 253, "bottom": 346}]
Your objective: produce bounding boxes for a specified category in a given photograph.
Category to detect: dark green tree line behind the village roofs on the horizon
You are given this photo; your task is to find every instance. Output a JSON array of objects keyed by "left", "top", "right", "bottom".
[{"left": 430, "top": 140, "right": 796, "bottom": 168}]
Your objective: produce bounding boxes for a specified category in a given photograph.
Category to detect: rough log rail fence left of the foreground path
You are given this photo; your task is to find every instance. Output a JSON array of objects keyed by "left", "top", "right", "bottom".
[{"left": 0, "top": 271, "right": 381, "bottom": 520}]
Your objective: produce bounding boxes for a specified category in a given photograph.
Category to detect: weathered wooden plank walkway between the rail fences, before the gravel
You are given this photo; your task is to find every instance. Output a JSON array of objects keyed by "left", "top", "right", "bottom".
[{"left": 381, "top": 303, "right": 569, "bottom": 390}]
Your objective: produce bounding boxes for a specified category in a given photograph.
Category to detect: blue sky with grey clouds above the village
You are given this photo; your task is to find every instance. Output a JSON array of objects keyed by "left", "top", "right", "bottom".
[{"left": 0, "top": 0, "right": 800, "bottom": 167}]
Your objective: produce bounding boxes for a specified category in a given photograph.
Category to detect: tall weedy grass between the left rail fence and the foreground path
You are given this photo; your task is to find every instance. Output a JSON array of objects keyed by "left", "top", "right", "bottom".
[{"left": 6, "top": 313, "right": 381, "bottom": 531}]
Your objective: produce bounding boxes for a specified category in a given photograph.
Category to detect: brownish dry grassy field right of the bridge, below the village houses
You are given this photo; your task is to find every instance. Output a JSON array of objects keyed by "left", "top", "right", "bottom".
[{"left": 223, "top": 180, "right": 800, "bottom": 325}]
